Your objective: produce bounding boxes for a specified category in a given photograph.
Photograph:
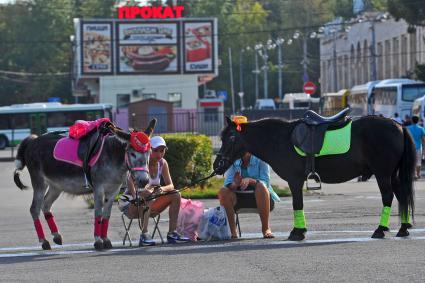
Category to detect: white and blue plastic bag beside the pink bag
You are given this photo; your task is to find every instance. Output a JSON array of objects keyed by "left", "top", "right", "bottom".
[{"left": 198, "top": 206, "right": 231, "bottom": 241}]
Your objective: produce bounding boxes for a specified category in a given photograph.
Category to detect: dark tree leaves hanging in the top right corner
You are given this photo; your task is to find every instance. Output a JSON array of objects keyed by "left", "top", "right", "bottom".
[{"left": 388, "top": 0, "right": 425, "bottom": 26}]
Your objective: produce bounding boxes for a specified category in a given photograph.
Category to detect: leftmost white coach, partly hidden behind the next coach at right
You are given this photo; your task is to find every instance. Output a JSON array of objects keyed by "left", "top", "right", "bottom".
[{"left": 348, "top": 81, "right": 379, "bottom": 116}]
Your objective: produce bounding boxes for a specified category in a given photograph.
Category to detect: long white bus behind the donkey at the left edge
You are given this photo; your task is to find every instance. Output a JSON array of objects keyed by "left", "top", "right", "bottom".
[{"left": 0, "top": 102, "right": 112, "bottom": 149}]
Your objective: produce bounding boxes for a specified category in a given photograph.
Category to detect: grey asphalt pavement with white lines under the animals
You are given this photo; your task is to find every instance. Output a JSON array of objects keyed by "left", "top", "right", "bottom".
[{"left": 0, "top": 154, "right": 425, "bottom": 282}]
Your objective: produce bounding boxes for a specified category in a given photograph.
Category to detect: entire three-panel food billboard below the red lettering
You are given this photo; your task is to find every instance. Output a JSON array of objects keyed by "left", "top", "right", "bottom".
[{"left": 75, "top": 18, "right": 218, "bottom": 77}]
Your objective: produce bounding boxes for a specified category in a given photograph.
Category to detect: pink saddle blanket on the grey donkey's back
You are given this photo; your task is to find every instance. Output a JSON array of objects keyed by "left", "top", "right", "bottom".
[{"left": 53, "top": 138, "right": 105, "bottom": 167}]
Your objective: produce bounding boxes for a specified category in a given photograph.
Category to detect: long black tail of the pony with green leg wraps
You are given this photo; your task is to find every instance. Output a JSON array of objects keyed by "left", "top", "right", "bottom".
[{"left": 399, "top": 127, "right": 416, "bottom": 224}]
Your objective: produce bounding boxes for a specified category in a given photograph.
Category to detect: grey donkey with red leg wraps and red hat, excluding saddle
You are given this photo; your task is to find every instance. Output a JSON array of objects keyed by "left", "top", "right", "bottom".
[{"left": 14, "top": 119, "right": 156, "bottom": 250}]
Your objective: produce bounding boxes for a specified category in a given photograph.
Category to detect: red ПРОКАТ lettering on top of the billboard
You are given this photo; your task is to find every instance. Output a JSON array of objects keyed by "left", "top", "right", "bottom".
[{"left": 118, "top": 6, "right": 184, "bottom": 19}]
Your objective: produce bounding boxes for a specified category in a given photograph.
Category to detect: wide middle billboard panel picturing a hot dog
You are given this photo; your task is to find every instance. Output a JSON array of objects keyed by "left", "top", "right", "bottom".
[{"left": 117, "top": 22, "right": 180, "bottom": 74}]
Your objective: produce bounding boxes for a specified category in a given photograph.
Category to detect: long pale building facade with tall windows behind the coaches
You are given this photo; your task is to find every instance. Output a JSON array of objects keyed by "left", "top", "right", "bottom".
[{"left": 320, "top": 13, "right": 425, "bottom": 93}]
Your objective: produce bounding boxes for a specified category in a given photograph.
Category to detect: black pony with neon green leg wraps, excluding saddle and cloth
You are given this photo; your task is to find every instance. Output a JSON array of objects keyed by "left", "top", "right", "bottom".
[{"left": 214, "top": 116, "right": 416, "bottom": 241}]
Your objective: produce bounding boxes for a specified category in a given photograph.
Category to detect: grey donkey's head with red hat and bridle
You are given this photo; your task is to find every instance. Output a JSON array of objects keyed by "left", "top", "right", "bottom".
[{"left": 112, "top": 119, "right": 156, "bottom": 188}]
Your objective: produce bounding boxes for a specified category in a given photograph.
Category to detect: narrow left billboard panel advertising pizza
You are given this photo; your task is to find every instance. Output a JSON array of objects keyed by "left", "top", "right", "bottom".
[{"left": 81, "top": 22, "right": 113, "bottom": 75}]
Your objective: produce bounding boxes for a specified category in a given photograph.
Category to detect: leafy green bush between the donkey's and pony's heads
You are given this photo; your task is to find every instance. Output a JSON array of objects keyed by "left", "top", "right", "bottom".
[{"left": 163, "top": 134, "right": 213, "bottom": 189}]
